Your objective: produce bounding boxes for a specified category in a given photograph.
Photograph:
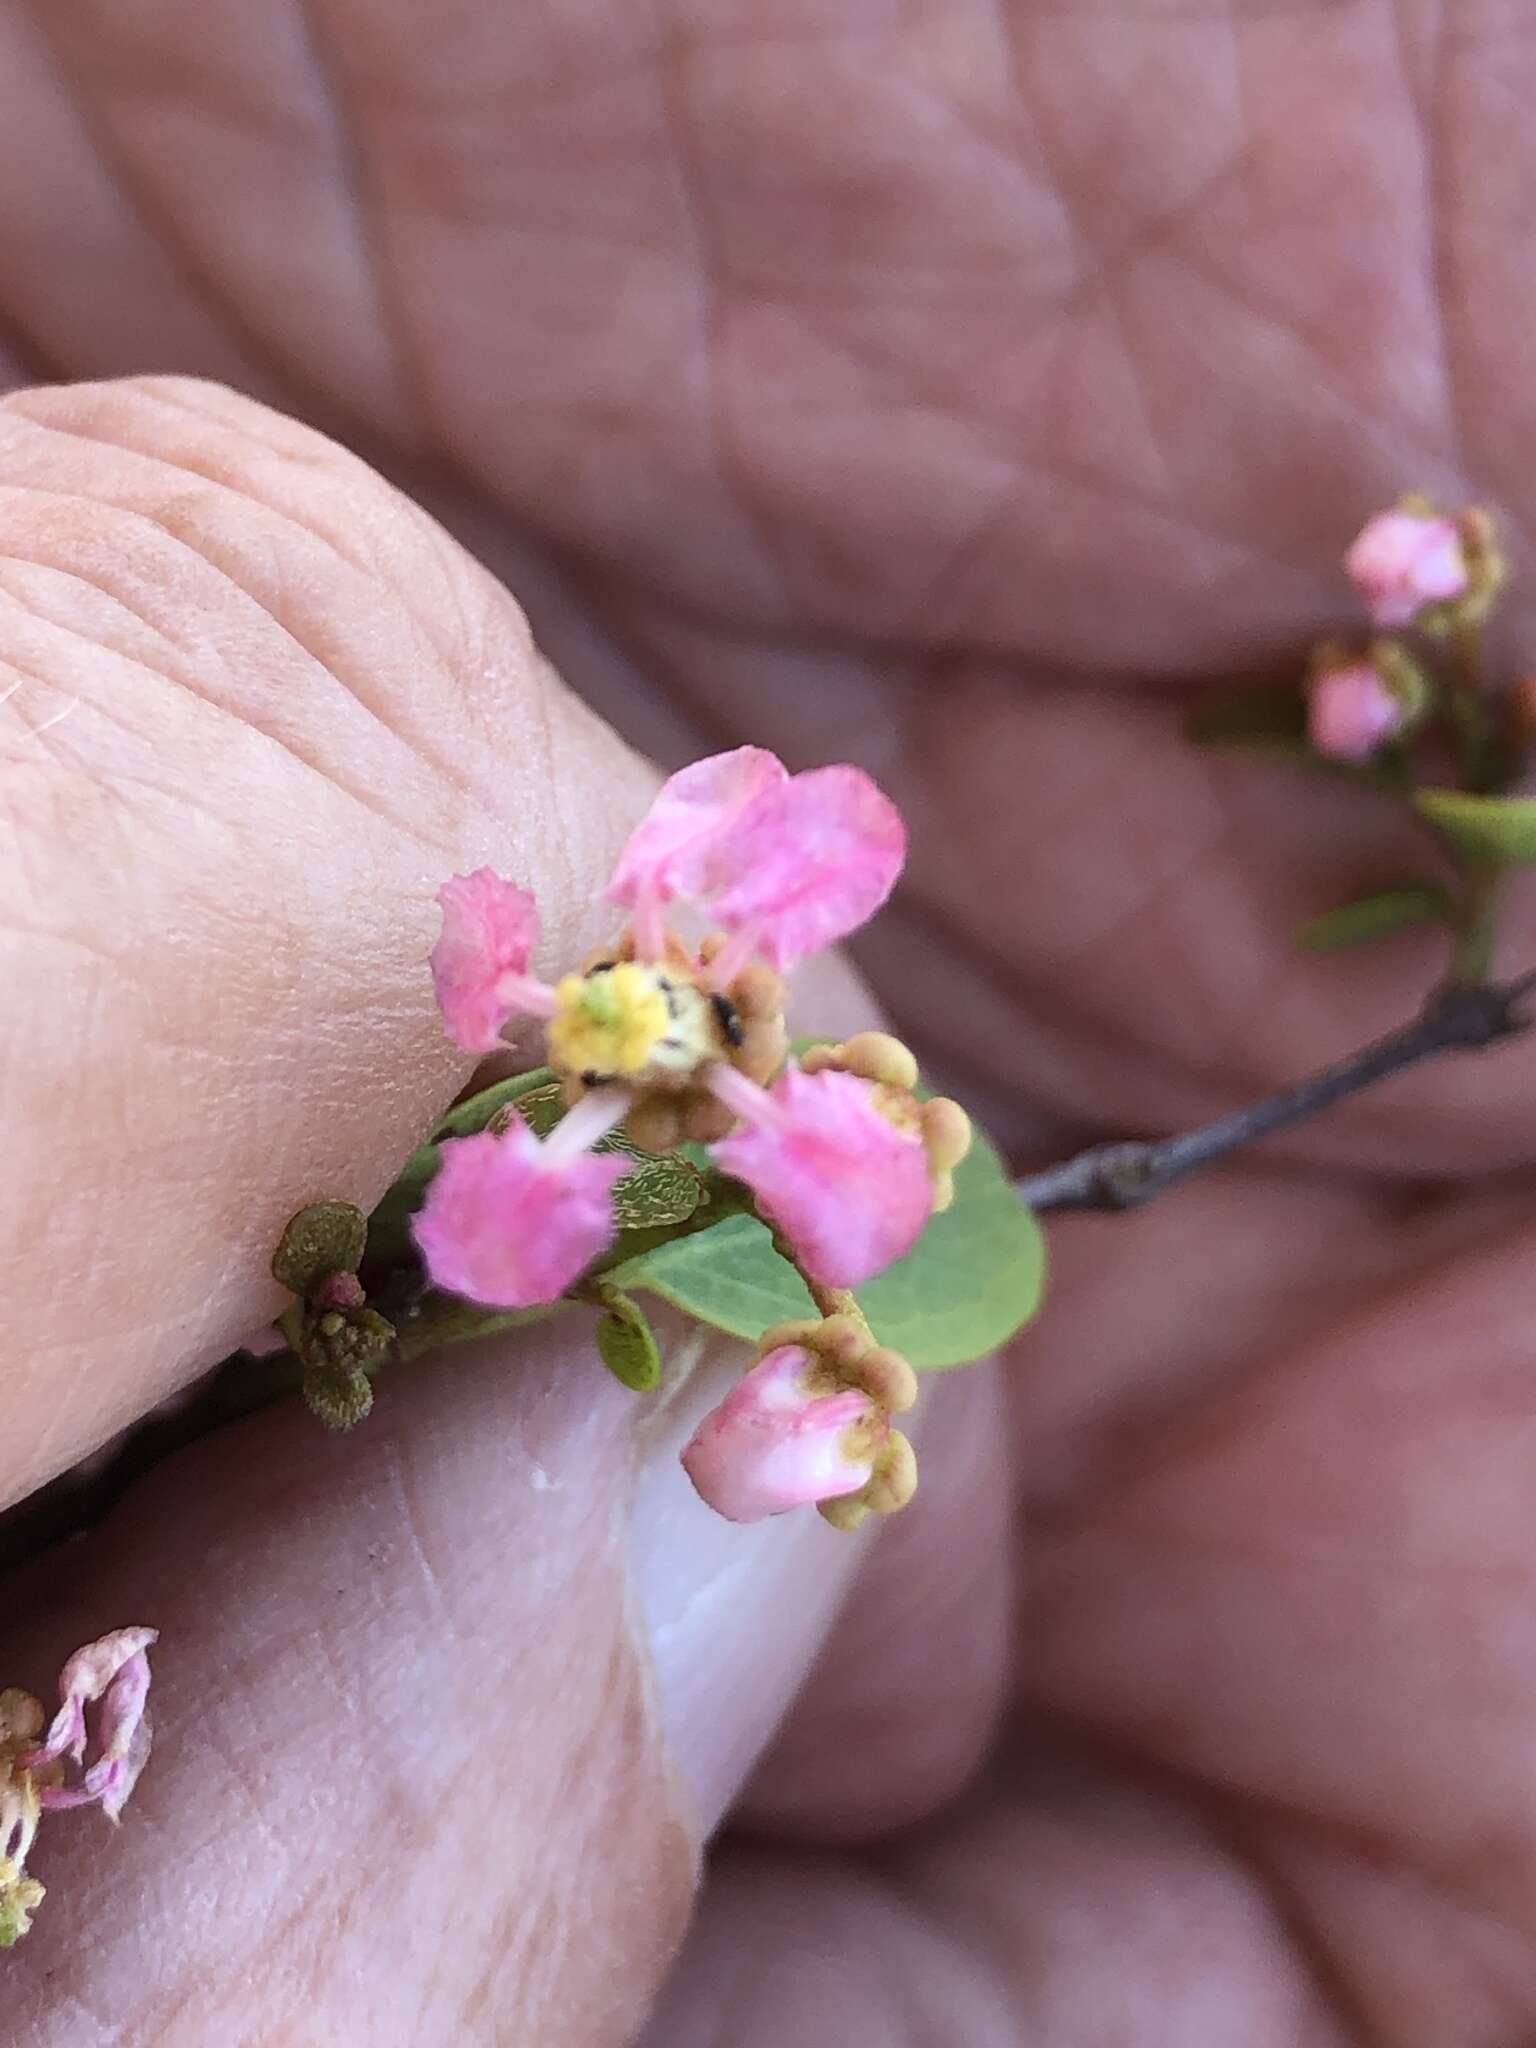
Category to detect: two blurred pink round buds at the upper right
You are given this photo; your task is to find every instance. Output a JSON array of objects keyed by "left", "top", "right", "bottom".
[{"left": 1307, "top": 498, "right": 1505, "bottom": 764}]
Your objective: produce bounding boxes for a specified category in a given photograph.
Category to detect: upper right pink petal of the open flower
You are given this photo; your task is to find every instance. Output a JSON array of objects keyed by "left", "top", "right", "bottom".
[{"left": 698, "top": 766, "right": 907, "bottom": 971}]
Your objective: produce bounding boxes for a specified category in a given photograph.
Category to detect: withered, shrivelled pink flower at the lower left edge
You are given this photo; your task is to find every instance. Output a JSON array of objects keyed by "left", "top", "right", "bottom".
[{"left": 0, "top": 1628, "right": 156, "bottom": 1948}]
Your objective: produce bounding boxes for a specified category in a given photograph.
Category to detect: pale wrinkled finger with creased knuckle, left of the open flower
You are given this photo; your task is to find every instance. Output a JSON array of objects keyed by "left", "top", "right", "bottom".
[{"left": 0, "top": 381, "right": 647, "bottom": 1497}]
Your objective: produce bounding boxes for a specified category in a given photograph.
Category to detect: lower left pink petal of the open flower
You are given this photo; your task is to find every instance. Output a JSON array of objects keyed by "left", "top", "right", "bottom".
[{"left": 412, "top": 1120, "right": 627, "bottom": 1309}]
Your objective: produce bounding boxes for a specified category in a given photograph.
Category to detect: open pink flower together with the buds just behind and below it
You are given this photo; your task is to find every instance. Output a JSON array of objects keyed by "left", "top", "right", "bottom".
[{"left": 414, "top": 748, "right": 971, "bottom": 1526}]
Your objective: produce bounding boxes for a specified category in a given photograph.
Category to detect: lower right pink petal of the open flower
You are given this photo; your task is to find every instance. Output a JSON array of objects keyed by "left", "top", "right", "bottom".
[{"left": 711, "top": 1067, "right": 934, "bottom": 1286}]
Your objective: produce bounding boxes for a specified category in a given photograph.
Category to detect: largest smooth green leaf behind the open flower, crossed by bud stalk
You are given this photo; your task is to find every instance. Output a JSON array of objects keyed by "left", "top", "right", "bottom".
[{"left": 610, "top": 1097, "right": 1044, "bottom": 1372}]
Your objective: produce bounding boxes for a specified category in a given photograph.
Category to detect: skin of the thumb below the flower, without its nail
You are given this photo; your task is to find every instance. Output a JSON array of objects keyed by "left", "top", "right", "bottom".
[{"left": 6, "top": 1339, "right": 696, "bottom": 2048}]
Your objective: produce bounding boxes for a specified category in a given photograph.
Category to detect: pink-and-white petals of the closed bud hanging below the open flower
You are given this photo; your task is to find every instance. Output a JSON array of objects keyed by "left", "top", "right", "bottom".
[{"left": 682, "top": 1343, "right": 891, "bottom": 1522}]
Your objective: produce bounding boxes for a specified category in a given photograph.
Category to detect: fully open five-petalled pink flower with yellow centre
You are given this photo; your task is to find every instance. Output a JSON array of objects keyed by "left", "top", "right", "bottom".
[{"left": 414, "top": 748, "right": 932, "bottom": 1309}]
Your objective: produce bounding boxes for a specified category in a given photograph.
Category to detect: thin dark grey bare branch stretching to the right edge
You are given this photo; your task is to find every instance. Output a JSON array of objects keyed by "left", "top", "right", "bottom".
[{"left": 1014, "top": 973, "right": 1536, "bottom": 1210}]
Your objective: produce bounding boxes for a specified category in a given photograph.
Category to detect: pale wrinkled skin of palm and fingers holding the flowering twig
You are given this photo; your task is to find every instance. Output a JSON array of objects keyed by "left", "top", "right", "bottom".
[{"left": 0, "top": 0, "right": 1536, "bottom": 2048}]
